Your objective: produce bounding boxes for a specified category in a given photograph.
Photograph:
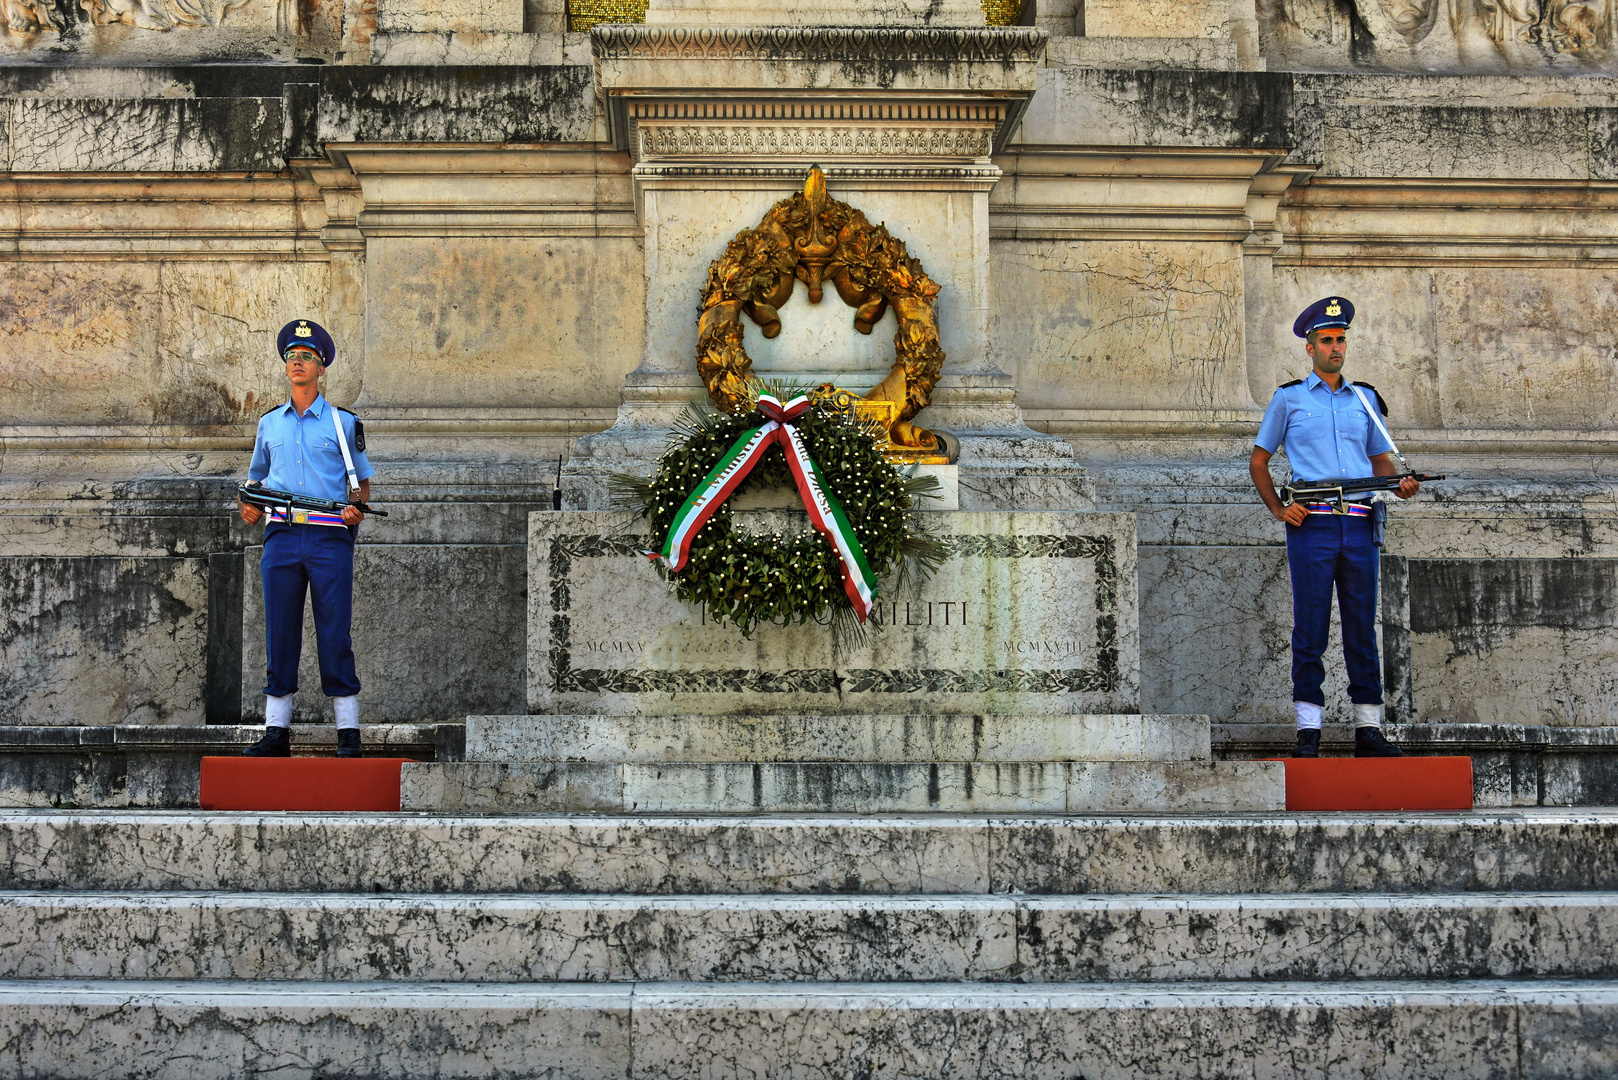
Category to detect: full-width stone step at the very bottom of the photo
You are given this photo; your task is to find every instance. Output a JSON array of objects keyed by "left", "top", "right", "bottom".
[{"left": 0, "top": 980, "right": 1618, "bottom": 1080}]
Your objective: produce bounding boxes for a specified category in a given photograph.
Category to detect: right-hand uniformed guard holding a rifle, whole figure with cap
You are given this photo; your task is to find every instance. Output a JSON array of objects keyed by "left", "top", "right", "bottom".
[{"left": 1247, "top": 296, "right": 1421, "bottom": 758}]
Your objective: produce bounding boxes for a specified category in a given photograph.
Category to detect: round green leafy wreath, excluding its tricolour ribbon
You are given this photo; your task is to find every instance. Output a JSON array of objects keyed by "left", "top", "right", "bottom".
[{"left": 613, "top": 384, "right": 948, "bottom": 638}]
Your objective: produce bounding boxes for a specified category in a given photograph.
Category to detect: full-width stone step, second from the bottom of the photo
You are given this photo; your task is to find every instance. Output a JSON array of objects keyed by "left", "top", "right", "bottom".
[{"left": 0, "top": 892, "right": 1618, "bottom": 983}]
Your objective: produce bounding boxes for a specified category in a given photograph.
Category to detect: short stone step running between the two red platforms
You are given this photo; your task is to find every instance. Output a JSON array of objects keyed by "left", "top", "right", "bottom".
[{"left": 400, "top": 761, "right": 1286, "bottom": 814}]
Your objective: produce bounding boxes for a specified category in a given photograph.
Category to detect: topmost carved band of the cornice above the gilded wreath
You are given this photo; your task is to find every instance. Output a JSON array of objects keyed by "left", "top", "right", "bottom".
[{"left": 591, "top": 24, "right": 1048, "bottom": 65}]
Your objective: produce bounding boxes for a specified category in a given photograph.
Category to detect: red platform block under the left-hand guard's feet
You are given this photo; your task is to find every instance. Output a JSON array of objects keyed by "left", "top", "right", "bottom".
[{"left": 197, "top": 758, "right": 408, "bottom": 810}]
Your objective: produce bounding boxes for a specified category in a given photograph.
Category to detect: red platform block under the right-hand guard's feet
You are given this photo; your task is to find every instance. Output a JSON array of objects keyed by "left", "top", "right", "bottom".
[{"left": 1281, "top": 758, "right": 1472, "bottom": 810}]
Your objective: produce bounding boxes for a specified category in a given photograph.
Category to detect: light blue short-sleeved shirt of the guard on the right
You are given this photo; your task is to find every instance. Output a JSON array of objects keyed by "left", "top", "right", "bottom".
[{"left": 1252, "top": 371, "right": 1393, "bottom": 483}]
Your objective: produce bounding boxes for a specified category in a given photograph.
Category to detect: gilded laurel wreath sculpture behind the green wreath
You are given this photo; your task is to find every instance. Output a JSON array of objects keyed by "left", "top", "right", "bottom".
[{"left": 697, "top": 165, "right": 943, "bottom": 450}]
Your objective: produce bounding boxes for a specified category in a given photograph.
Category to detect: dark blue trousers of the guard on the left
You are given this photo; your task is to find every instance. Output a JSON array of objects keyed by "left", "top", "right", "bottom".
[{"left": 259, "top": 525, "right": 359, "bottom": 698}]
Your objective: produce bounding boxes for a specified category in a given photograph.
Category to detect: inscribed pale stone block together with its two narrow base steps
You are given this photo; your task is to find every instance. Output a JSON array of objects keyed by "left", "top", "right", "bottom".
[{"left": 403, "top": 510, "right": 1285, "bottom": 813}]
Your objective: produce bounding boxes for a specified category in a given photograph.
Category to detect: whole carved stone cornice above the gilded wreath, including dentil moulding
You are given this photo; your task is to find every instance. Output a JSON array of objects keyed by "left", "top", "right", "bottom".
[{"left": 591, "top": 26, "right": 1047, "bottom": 158}]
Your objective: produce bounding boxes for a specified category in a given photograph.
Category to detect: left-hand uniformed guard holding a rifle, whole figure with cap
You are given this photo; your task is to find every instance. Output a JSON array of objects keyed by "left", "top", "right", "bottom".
[{"left": 241, "top": 319, "right": 375, "bottom": 758}]
